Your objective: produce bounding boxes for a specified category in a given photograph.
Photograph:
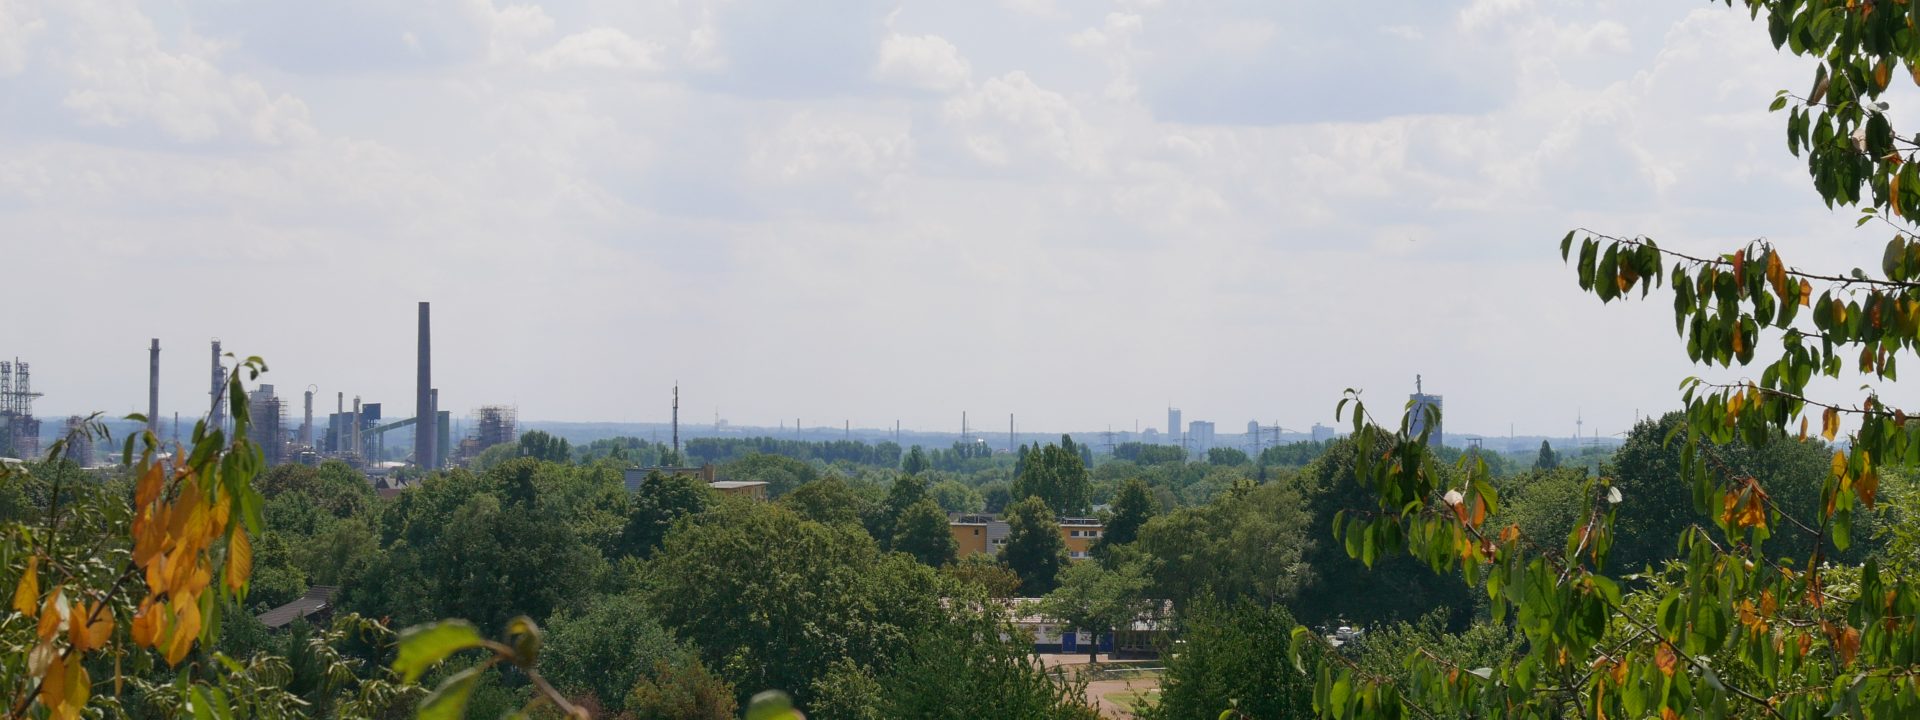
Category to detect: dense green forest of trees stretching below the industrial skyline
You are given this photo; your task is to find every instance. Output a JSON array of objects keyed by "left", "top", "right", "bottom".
[{"left": 15, "top": 368, "right": 1896, "bottom": 718}]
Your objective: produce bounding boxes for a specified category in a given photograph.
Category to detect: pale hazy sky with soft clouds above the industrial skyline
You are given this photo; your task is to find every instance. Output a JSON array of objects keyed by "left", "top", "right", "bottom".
[{"left": 0, "top": 0, "right": 1910, "bottom": 434}]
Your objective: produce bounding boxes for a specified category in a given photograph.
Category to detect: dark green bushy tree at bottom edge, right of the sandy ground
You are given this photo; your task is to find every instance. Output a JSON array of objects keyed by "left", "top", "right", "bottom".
[{"left": 1142, "top": 597, "right": 1315, "bottom": 720}]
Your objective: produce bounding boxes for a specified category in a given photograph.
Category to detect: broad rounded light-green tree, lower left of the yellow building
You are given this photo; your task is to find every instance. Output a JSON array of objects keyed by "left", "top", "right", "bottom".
[{"left": 647, "top": 503, "right": 941, "bottom": 707}]
